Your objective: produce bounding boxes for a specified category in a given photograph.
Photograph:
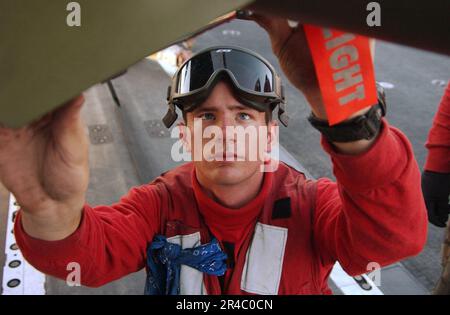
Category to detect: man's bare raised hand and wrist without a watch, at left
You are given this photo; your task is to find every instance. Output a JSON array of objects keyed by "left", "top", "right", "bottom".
[{"left": 0, "top": 95, "right": 89, "bottom": 240}]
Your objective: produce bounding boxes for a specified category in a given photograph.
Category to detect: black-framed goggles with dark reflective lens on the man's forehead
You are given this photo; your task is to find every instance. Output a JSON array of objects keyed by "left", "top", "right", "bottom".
[{"left": 163, "top": 46, "right": 289, "bottom": 128}]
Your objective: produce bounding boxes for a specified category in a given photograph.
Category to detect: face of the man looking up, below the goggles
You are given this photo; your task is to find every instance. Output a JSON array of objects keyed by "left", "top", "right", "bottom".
[{"left": 180, "top": 81, "right": 276, "bottom": 185}]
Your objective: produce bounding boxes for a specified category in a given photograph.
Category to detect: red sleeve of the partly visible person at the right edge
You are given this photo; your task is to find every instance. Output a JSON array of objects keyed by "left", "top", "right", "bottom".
[{"left": 425, "top": 83, "right": 450, "bottom": 173}]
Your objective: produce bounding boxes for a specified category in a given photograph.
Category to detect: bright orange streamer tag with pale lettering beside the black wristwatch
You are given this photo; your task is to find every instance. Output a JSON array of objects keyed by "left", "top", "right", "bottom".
[{"left": 304, "top": 25, "right": 378, "bottom": 125}]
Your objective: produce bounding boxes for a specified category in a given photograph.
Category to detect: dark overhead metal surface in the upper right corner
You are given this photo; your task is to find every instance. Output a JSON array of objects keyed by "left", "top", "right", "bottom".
[{"left": 251, "top": 0, "right": 450, "bottom": 55}]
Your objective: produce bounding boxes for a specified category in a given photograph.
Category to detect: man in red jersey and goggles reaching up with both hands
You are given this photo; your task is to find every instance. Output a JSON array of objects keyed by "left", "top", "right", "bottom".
[{"left": 0, "top": 18, "right": 427, "bottom": 294}]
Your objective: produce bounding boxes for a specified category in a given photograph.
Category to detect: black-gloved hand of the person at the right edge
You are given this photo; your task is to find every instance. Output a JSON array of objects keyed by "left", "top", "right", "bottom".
[{"left": 422, "top": 170, "right": 450, "bottom": 227}]
